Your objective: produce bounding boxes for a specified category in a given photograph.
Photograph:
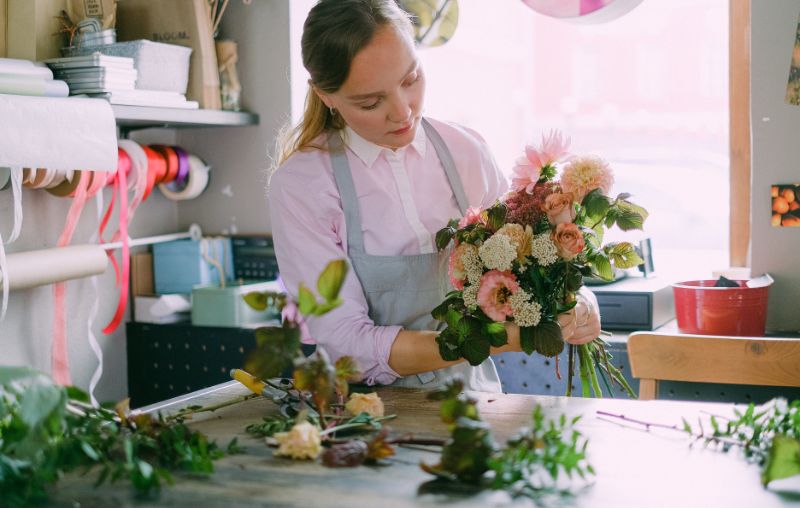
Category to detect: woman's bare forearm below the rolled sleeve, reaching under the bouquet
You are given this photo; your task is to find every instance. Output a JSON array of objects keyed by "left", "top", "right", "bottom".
[{"left": 389, "top": 323, "right": 521, "bottom": 376}]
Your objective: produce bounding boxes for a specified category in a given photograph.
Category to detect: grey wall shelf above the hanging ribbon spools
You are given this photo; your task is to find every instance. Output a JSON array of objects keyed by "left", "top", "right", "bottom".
[{"left": 111, "top": 104, "right": 259, "bottom": 131}]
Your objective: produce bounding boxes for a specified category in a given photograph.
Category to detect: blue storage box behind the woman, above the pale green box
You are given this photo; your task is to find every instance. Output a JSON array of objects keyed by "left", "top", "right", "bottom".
[{"left": 153, "top": 238, "right": 233, "bottom": 295}]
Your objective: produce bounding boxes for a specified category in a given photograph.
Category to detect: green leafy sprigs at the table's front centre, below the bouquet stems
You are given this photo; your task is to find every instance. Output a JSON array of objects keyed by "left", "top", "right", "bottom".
[{"left": 421, "top": 379, "right": 595, "bottom": 496}]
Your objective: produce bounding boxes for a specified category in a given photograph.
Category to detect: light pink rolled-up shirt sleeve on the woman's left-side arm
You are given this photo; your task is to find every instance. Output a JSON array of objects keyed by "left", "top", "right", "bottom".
[{"left": 267, "top": 151, "right": 402, "bottom": 385}]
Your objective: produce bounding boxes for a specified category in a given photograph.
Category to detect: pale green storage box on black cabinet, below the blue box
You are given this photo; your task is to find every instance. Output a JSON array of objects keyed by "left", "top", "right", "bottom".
[{"left": 192, "top": 281, "right": 280, "bottom": 327}]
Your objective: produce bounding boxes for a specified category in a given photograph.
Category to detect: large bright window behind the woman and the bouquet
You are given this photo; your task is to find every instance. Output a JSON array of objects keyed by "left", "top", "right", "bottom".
[{"left": 420, "top": 0, "right": 730, "bottom": 268}]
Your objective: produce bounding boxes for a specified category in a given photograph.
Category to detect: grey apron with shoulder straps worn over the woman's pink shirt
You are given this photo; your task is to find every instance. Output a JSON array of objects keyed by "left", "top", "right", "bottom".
[{"left": 328, "top": 119, "right": 501, "bottom": 392}]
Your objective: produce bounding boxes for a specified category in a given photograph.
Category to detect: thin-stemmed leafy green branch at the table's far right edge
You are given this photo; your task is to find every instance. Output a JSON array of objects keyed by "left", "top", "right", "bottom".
[{"left": 598, "top": 398, "right": 800, "bottom": 487}]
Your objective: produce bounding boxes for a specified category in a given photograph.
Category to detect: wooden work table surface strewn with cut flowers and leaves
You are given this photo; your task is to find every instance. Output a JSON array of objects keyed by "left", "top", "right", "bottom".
[{"left": 52, "top": 383, "right": 800, "bottom": 508}]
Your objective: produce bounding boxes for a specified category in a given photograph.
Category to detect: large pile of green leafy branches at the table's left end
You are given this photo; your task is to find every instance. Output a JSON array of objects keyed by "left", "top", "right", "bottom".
[{"left": 0, "top": 367, "right": 230, "bottom": 507}]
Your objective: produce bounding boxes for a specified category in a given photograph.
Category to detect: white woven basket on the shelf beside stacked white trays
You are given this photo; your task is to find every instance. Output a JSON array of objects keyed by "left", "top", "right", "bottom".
[{"left": 63, "top": 39, "right": 192, "bottom": 94}]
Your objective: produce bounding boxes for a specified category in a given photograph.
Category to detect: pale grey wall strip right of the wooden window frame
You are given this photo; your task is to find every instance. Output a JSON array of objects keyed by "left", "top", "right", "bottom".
[{"left": 750, "top": 0, "right": 800, "bottom": 331}]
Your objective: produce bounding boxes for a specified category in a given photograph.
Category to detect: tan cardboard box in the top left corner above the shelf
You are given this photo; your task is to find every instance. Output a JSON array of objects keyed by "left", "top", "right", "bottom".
[{"left": 6, "top": 0, "right": 67, "bottom": 61}]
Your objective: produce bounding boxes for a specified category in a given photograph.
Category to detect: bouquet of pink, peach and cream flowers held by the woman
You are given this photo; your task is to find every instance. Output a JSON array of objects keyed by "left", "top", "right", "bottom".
[{"left": 432, "top": 131, "right": 647, "bottom": 397}]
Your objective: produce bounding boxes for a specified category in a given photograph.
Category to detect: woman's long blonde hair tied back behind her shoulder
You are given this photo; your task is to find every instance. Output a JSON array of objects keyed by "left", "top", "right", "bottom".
[{"left": 275, "top": 0, "right": 413, "bottom": 165}]
